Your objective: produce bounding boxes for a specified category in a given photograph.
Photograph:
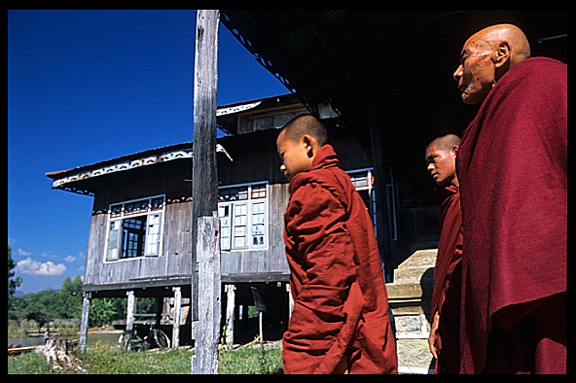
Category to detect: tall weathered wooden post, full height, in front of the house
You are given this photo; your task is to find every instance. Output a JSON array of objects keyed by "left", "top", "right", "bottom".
[{"left": 191, "top": 10, "right": 221, "bottom": 374}]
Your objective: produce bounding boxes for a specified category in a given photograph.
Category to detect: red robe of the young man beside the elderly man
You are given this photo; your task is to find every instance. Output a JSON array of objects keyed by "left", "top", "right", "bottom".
[{"left": 431, "top": 185, "right": 463, "bottom": 374}]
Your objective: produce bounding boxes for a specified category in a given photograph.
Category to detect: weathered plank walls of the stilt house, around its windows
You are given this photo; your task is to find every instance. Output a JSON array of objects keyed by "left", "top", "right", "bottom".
[{"left": 76, "top": 121, "right": 372, "bottom": 291}]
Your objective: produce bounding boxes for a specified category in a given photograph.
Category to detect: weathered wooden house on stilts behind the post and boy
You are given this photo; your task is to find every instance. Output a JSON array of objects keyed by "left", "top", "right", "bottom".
[{"left": 47, "top": 95, "right": 375, "bottom": 344}]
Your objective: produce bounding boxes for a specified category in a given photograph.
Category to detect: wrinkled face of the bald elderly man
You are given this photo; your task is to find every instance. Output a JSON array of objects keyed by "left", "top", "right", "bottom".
[{"left": 454, "top": 35, "right": 496, "bottom": 105}]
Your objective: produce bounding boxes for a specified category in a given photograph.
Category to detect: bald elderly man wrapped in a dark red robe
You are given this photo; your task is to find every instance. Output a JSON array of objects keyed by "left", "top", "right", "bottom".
[{"left": 454, "top": 24, "right": 568, "bottom": 373}]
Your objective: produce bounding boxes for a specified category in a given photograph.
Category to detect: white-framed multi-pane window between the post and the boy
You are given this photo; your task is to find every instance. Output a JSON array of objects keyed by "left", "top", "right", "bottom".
[{"left": 218, "top": 183, "right": 268, "bottom": 250}]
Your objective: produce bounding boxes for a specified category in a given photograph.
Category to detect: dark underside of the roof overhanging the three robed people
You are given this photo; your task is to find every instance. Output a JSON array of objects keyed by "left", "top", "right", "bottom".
[{"left": 221, "top": 10, "right": 568, "bottom": 162}]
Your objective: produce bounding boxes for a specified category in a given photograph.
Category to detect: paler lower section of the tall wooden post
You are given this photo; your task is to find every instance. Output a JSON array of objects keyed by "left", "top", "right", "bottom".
[{"left": 192, "top": 212, "right": 221, "bottom": 374}]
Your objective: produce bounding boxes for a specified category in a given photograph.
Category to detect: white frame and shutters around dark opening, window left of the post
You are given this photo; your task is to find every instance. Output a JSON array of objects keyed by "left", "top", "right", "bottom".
[{"left": 104, "top": 194, "right": 166, "bottom": 263}]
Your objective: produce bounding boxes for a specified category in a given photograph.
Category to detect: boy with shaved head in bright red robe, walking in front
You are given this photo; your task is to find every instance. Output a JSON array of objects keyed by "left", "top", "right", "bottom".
[{"left": 276, "top": 115, "right": 397, "bottom": 374}]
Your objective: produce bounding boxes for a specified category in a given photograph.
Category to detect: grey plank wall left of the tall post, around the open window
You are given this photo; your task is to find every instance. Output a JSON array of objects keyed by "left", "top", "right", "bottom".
[{"left": 84, "top": 164, "right": 192, "bottom": 290}]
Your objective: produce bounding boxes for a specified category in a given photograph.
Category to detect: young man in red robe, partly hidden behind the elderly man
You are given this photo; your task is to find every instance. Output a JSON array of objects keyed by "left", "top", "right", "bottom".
[{"left": 425, "top": 134, "right": 462, "bottom": 374}]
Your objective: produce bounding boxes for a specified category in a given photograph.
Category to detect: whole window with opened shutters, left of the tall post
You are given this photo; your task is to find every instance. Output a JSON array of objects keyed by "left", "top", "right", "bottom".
[{"left": 106, "top": 196, "right": 164, "bottom": 261}]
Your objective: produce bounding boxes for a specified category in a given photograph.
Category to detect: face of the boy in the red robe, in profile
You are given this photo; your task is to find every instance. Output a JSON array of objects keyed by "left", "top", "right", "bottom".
[{"left": 276, "top": 131, "right": 314, "bottom": 181}]
